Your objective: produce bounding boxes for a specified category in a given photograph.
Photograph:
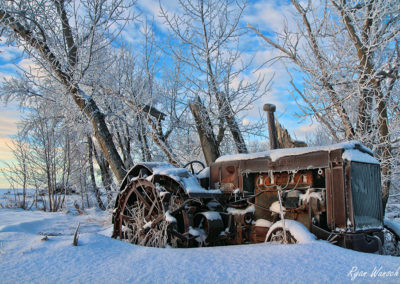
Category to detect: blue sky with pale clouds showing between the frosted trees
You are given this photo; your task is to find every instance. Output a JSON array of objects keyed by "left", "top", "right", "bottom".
[{"left": 0, "top": 0, "right": 317, "bottom": 188}]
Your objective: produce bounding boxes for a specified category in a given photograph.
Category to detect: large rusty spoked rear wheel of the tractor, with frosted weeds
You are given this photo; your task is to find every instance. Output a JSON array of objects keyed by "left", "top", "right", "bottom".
[{"left": 113, "top": 179, "right": 188, "bottom": 247}]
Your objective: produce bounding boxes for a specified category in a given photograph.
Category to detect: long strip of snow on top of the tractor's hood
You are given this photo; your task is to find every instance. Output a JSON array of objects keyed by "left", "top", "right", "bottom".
[{"left": 215, "top": 141, "right": 377, "bottom": 163}]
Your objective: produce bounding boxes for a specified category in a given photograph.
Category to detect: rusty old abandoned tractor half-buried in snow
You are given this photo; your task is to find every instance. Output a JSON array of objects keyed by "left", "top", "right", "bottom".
[{"left": 113, "top": 104, "right": 399, "bottom": 252}]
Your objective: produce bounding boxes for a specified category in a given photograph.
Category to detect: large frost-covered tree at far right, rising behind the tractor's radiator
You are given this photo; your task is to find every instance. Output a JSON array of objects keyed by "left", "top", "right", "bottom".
[{"left": 251, "top": 0, "right": 400, "bottom": 211}]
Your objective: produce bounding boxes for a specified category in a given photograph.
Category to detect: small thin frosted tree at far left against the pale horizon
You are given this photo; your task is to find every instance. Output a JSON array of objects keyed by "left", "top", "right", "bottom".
[{"left": 8, "top": 107, "right": 72, "bottom": 212}]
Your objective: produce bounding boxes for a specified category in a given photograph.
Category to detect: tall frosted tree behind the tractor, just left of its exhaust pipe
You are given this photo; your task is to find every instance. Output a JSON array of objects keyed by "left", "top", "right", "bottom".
[{"left": 161, "top": 0, "right": 268, "bottom": 160}]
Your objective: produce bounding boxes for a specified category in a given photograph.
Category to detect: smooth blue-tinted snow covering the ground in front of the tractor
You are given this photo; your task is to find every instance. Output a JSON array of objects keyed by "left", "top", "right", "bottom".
[{"left": 0, "top": 190, "right": 400, "bottom": 283}]
